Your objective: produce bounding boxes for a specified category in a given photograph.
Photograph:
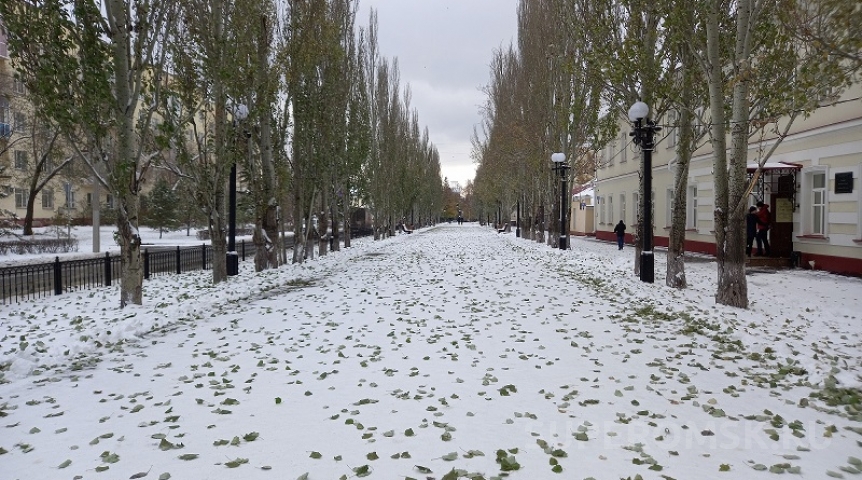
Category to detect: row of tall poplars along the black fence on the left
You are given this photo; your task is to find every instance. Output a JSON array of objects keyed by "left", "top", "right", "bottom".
[{"left": 0, "top": 0, "right": 446, "bottom": 306}]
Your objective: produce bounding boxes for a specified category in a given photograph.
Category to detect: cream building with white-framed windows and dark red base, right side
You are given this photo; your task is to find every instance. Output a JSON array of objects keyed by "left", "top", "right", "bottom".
[{"left": 594, "top": 84, "right": 862, "bottom": 275}]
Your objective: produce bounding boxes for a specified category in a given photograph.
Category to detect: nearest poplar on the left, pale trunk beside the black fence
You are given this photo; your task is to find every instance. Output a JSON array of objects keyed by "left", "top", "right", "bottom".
[{"left": 0, "top": 0, "right": 177, "bottom": 307}]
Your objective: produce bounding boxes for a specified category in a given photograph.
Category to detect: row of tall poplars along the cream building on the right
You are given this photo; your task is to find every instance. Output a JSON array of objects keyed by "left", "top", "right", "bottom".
[{"left": 474, "top": 0, "right": 862, "bottom": 308}]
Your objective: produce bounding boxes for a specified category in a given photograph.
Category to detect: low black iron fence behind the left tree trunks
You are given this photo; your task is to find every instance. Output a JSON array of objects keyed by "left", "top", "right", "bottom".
[{"left": 0, "top": 241, "right": 260, "bottom": 304}]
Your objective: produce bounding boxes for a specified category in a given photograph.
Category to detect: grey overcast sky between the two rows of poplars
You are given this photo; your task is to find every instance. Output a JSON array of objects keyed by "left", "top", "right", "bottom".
[{"left": 357, "top": 0, "right": 518, "bottom": 191}]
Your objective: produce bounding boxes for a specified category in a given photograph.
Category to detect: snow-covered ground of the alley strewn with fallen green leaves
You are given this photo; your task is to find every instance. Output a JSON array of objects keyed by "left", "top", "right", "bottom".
[{"left": 0, "top": 224, "right": 862, "bottom": 480}]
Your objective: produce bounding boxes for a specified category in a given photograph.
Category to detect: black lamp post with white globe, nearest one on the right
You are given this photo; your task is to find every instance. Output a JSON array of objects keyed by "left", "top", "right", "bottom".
[{"left": 629, "top": 101, "right": 661, "bottom": 283}]
